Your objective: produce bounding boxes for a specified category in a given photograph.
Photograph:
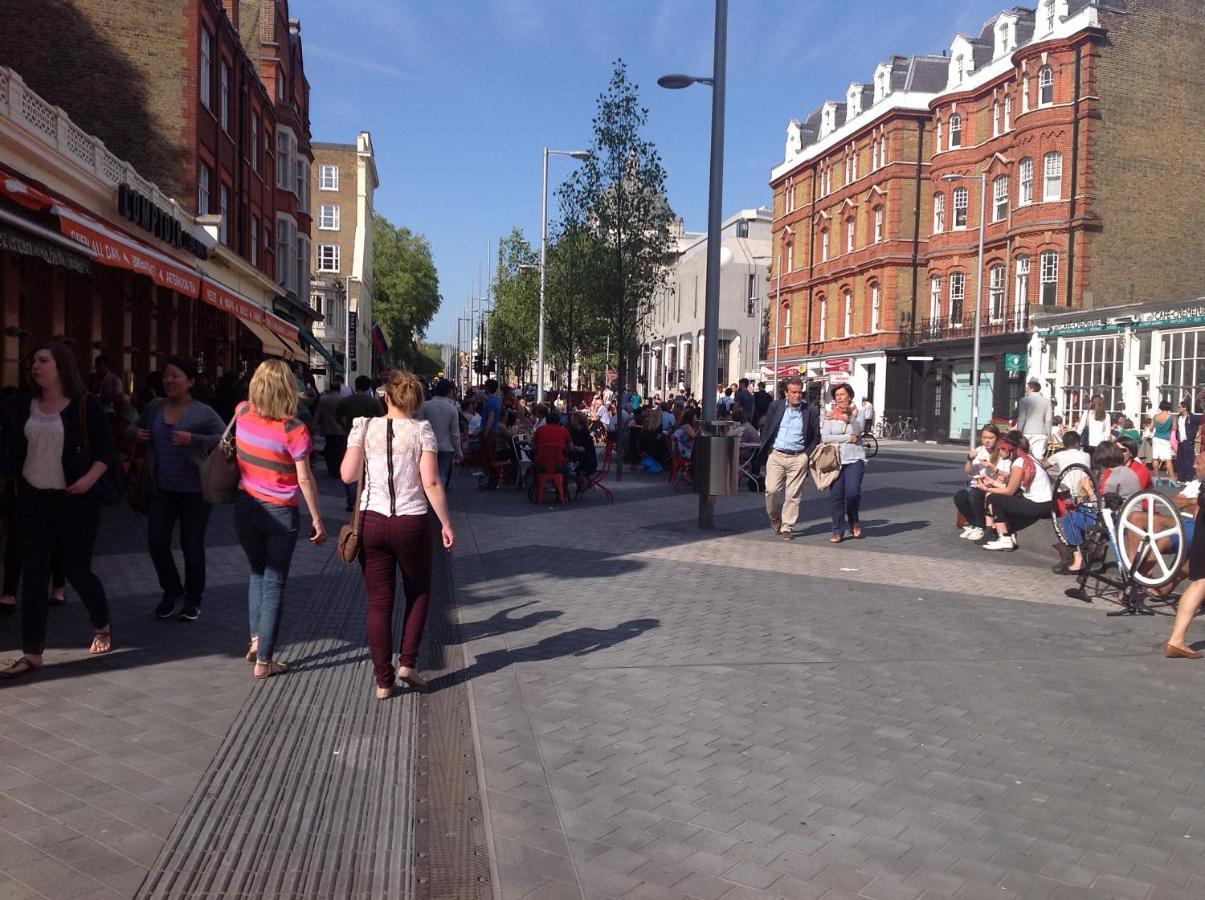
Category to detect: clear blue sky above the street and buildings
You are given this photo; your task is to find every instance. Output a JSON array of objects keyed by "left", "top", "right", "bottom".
[{"left": 289, "top": 0, "right": 1012, "bottom": 342}]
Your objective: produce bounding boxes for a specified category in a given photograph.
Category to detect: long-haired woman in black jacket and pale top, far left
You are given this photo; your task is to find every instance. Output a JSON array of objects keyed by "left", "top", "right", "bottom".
[{"left": 0, "top": 341, "right": 117, "bottom": 678}]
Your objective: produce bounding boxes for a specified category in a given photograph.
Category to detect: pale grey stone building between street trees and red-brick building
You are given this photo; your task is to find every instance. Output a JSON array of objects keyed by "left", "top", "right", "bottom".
[{"left": 637, "top": 207, "right": 771, "bottom": 396}]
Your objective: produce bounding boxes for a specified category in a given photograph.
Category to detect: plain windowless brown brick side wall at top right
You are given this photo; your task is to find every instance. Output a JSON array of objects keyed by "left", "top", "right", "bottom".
[{"left": 1083, "top": 0, "right": 1205, "bottom": 306}]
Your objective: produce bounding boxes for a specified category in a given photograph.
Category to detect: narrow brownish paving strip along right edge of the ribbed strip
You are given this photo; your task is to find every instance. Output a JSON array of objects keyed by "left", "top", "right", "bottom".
[{"left": 413, "top": 539, "right": 494, "bottom": 900}]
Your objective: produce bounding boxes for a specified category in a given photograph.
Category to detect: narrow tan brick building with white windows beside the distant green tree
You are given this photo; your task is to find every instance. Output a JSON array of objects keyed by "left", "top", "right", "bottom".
[{"left": 310, "top": 131, "right": 381, "bottom": 378}]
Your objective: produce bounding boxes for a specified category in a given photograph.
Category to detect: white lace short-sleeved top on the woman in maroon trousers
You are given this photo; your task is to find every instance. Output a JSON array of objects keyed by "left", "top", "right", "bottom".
[{"left": 347, "top": 416, "right": 439, "bottom": 516}]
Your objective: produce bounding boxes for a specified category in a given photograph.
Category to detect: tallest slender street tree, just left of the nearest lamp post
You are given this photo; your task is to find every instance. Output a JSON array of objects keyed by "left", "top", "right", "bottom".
[{"left": 558, "top": 59, "right": 674, "bottom": 477}]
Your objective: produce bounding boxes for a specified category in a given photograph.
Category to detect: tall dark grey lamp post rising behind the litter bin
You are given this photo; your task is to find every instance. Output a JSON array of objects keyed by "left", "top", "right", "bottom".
[{"left": 657, "top": 0, "right": 728, "bottom": 528}]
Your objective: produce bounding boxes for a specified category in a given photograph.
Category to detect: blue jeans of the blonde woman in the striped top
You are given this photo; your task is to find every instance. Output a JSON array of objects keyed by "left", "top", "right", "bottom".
[{"left": 234, "top": 490, "right": 299, "bottom": 663}]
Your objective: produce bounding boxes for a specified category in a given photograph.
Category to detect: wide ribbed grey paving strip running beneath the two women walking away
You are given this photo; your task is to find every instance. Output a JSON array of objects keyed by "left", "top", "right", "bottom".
[{"left": 137, "top": 554, "right": 418, "bottom": 900}]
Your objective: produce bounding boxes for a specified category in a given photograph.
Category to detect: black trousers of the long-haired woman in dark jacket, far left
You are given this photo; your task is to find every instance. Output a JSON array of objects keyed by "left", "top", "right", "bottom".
[{"left": 17, "top": 482, "right": 108, "bottom": 655}]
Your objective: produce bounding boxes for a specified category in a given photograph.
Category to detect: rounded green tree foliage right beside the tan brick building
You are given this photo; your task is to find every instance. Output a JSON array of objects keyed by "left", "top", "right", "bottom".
[{"left": 372, "top": 213, "right": 440, "bottom": 369}]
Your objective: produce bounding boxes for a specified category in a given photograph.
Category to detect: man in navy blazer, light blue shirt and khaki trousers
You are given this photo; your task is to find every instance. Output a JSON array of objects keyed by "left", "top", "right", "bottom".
[{"left": 753, "top": 377, "right": 821, "bottom": 541}]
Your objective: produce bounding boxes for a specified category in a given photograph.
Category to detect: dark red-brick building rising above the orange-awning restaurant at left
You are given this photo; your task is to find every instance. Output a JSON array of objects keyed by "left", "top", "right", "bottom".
[{"left": 0, "top": 0, "right": 312, "bottom": 383}]
